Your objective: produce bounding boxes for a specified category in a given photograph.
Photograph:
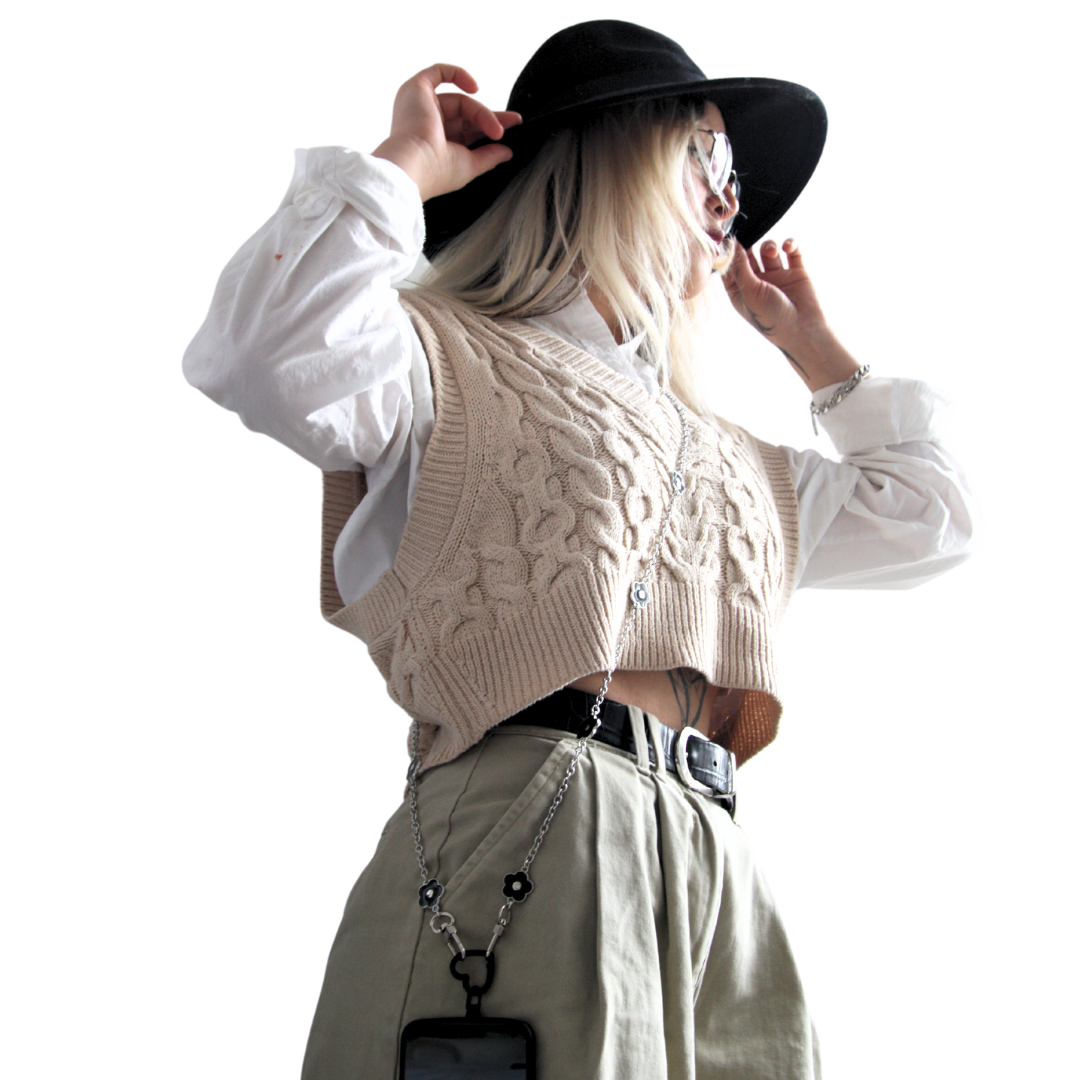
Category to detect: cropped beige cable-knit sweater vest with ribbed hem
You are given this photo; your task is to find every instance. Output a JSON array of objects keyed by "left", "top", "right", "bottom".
[{"left": 323, "top": 291, "right": 798, "bottom": 768}]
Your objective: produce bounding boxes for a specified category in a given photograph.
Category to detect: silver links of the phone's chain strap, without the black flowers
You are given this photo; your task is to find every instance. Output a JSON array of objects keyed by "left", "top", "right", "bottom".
[{"left": 408, "top": 390, "right": 690, "bottom": 956}]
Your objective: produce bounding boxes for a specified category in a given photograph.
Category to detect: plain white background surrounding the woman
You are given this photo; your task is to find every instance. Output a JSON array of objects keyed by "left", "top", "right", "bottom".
[{"left": 0, "top": 0, "right": 1080, "bottom": 1080}]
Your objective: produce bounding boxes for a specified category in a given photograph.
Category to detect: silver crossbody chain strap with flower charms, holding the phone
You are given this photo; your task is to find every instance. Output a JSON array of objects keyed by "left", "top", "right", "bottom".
[{"left": 408, "top": 390, "right": 690, "bottom": 957}]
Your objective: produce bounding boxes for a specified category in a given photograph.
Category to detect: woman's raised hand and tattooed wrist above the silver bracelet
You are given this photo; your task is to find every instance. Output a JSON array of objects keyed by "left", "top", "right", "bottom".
[{"left": 724, "top": 240, "right": 859, "bottom": 391}]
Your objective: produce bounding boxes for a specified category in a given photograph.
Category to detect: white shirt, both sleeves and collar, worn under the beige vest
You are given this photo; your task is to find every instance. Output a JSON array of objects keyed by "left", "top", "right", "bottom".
[{"left": 184, "top": 147, "right": 973, "bottom": 604}]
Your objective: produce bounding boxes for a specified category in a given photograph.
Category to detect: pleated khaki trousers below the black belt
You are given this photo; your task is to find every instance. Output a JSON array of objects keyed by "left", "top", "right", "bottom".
[{"left": 303, "top": 708, "right": 819, "bottom": 1080}]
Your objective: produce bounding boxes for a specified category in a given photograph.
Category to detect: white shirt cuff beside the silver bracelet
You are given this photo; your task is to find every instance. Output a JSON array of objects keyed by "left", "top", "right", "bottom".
[{"left": 813, "top": 378, "right": 948, "bottom": 457}]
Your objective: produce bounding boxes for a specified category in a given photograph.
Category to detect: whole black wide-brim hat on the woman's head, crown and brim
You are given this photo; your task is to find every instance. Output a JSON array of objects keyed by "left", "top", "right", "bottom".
[{"left": 423, "top": 19, "right": 827, "bottom": 258}]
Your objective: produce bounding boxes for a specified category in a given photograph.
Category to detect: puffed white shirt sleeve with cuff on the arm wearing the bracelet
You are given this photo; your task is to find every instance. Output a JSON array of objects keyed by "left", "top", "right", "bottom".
[{"left": 781, "top": 378, "right": 976, "bottom": 589}]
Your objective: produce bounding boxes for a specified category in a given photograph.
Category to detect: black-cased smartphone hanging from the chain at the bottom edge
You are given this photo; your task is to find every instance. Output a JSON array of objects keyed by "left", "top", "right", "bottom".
[{"left": 397, "top": 1016, "right": 537, "bottom": 1080}]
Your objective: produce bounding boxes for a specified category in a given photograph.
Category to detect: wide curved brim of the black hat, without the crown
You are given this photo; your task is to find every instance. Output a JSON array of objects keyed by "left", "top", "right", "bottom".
[{"left": 423, "top": 79, "right": 828, "bottom": 258}]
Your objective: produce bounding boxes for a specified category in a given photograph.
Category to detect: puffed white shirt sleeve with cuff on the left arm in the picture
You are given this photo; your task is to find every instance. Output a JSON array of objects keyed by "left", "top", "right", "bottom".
[{"left": 184, "top": 147, "right": 423, "bottom": 470}]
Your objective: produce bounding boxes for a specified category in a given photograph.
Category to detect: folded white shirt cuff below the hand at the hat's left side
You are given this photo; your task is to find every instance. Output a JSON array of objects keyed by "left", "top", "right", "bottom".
[{"left": 289, "top": 146, "right": 424, "bottom": 257}]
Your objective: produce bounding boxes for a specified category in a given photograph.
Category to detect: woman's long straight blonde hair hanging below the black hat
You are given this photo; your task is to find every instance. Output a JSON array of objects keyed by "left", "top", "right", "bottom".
[{"left": 423, "top": 98, "right": 730, "bottom": 418}]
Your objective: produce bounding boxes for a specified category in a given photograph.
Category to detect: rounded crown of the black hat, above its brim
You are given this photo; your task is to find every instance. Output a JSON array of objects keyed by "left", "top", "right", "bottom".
[{"left": 507, "top": 18, "right": 705, "bottom": 122}]
